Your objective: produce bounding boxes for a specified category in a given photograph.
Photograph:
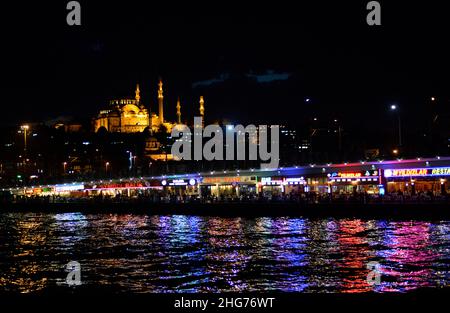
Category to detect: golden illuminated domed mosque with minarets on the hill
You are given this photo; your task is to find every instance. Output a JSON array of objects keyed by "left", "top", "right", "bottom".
[{"left": 93, "top": 80, "right": 205, "bottom": 133}]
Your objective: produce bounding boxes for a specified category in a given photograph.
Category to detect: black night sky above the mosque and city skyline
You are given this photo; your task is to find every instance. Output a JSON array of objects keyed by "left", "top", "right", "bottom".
[{"left": 0, "top": 1, "right": 450, "bottom": 141}]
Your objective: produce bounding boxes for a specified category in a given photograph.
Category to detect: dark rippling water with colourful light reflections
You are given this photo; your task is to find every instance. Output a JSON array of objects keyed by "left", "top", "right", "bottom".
[{"left": 0, "top": 213, "right": 450, "bottom": 293}]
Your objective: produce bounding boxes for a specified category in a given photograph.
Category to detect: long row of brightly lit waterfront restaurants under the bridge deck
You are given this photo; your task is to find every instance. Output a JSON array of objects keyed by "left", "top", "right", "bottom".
[{"left": 3, "top": 157, "right": 450, "bottom": 198}]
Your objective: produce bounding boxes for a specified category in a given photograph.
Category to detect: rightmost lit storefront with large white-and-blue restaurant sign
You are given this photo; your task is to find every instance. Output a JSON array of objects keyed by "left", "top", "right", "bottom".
[{"left": 384, "top": 167, "right": 450, "bottom": 195}]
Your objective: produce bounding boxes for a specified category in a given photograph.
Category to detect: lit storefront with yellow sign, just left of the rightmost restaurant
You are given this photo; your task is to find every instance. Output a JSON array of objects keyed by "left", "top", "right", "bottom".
[{"left": 327, "top": 169, "right": 381, "bottom": 194}]
